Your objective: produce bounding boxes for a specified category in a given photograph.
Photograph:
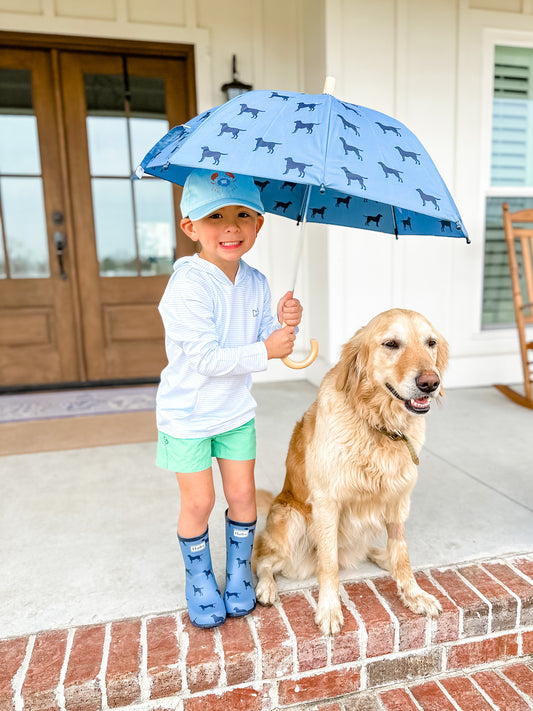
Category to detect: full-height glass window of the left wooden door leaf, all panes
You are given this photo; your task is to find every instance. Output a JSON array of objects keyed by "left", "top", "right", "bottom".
[{"left": 0, "top": 68, "right": 50, "bottom": 279}]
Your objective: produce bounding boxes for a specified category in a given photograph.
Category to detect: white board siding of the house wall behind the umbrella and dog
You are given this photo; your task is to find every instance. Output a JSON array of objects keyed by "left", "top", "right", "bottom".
[{"left": 0, "top": 0, "right": 533, "bottom": 387}]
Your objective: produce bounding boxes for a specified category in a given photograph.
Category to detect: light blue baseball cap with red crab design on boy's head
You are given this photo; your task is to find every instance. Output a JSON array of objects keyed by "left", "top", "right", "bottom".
[{"left": 181, "top": 169, "right": 265, "bottom": 220}]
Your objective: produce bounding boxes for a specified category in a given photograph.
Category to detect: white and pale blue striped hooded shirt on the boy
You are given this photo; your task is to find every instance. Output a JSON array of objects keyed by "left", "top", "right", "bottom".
[{"left": 157, "top": 254, "right": 280, "bottom": 438}]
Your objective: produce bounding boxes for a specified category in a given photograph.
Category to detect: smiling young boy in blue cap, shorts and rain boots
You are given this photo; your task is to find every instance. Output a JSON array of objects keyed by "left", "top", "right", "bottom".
[{"left": 157, "top": 170, "right": 302, "bottom": 627}]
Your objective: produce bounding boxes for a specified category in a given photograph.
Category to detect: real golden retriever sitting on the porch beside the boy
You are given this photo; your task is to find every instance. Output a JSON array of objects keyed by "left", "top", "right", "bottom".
[{"left": 252, "top": 309, "right": 448, "bottom": 635}]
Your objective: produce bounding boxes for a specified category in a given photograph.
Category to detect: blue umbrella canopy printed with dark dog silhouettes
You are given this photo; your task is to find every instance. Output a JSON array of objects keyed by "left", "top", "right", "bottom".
[{"left": 136, "top": 86, "right": 469, "bottom": 241}]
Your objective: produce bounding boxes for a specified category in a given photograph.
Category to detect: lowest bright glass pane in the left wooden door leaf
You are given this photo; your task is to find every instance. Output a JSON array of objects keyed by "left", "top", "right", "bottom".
[{"left": 0, "top": 177, "right": 50, "bottom": 279}]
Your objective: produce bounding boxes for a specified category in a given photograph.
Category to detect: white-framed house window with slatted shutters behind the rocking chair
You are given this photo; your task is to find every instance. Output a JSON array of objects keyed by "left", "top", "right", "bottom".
[{"left": 482, "top": 41, "right": 533, "bottom": 328}]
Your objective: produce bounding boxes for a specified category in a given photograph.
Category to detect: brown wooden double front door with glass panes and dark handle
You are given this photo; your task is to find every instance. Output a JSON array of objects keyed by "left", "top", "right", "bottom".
[{"left": 0, "top": 39, "right": 195, "bottom": 388}]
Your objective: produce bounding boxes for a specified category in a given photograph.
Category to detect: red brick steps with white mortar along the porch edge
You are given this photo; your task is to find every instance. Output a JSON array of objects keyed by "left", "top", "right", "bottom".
[{"left": 0, "top": 554, "right": 533, "bottom": 711}]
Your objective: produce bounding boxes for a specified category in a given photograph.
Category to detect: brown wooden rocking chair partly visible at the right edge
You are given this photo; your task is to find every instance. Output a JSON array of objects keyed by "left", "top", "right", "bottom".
[{"left": 496, "top": 203, "right": 533, "bottom": 409}]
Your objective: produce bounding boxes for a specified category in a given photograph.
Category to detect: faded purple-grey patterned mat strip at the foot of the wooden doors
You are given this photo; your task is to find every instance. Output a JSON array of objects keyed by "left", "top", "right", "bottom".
[{"left": 0, "top": 385, "right": 157, "bottom": 423}]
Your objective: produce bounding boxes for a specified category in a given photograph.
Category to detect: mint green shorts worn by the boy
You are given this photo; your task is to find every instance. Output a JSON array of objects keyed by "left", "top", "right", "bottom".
[{"left": 156, "top": 420, "right": 255, "bottom": 474}]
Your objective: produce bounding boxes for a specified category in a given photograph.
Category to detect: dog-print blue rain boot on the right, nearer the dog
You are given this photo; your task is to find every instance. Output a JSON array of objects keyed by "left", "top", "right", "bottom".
[{"left": 224, "top": 511, "right": 256, "bottom": 617}]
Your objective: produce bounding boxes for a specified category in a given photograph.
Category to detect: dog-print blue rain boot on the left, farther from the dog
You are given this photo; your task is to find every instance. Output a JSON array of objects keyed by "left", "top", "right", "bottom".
[{"left": 178, "top": 530, "right": 226, "bottom": 627}]
